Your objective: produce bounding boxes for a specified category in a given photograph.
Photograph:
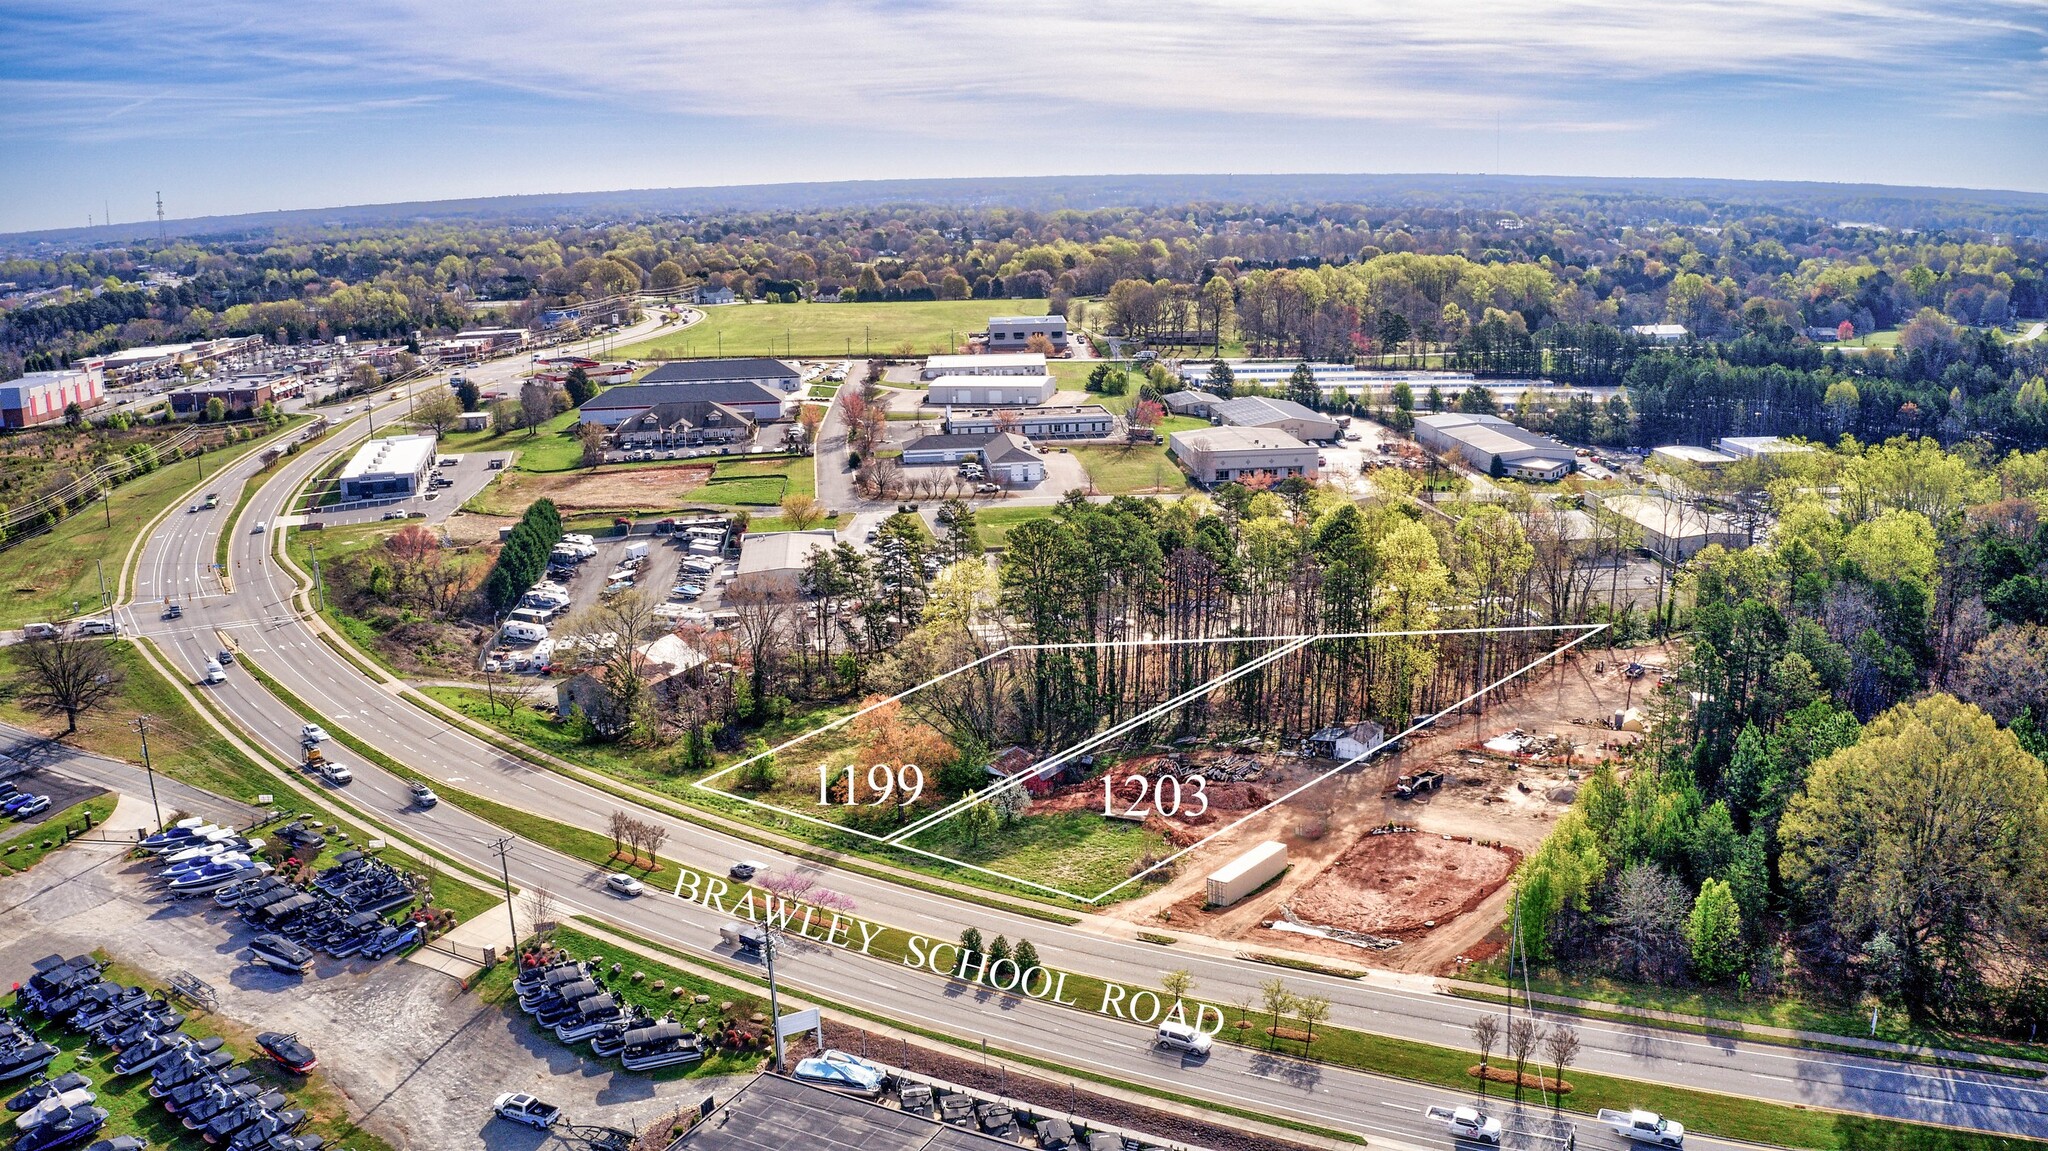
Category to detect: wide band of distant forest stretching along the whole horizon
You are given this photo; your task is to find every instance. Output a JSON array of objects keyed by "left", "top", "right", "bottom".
[{"left": 0, "top": 193, "right": 2048, "bottom": 446}]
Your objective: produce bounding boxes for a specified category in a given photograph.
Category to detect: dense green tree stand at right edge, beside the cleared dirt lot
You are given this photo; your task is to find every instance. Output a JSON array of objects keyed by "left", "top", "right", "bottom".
[{"left": 1518, "top": 440, "right": 2048, "bottom": 1038}]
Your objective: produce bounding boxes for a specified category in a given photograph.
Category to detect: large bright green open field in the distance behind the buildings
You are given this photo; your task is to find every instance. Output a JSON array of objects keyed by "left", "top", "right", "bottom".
[{"left": 612, "top": 299, "right": 1044, "bottom": 360}]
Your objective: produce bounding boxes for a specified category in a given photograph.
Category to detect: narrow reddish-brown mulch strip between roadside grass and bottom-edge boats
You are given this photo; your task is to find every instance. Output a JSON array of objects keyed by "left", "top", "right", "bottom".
[{"left": 784, "top": 1020, "right": 1305, "bottom": 1151}]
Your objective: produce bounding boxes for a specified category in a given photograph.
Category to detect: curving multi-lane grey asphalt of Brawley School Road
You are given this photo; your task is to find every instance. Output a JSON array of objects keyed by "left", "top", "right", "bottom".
[{"left": 72, "top": 311, "right": 2048, "bottom": 1147}]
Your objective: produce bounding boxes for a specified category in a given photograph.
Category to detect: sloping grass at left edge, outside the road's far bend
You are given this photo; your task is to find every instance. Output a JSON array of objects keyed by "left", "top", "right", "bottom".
[{"left": 0, "top": 432, "right": 299, "bottom": 627}]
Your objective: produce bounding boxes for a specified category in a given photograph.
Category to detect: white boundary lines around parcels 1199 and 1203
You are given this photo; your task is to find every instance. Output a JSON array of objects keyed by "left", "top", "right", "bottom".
[{"left": 692, "top": 623, "right": 1608, "bottom": 903}]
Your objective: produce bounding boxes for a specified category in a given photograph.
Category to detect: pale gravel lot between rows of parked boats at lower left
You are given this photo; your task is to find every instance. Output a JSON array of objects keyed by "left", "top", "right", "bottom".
[{"left": 0, "top": 811, "right": 741, "bottom": 1151}]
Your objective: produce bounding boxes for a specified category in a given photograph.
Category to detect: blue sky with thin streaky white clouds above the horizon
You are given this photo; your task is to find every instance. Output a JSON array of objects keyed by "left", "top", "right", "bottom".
[{"left": 0, "top": 0, "right": 2048, "bottom": 231}]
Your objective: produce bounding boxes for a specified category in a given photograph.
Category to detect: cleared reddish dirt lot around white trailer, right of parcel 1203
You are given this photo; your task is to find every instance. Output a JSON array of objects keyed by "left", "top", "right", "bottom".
[{"left": 1114, "top": 647, "right": 1675, "bottom": 973}]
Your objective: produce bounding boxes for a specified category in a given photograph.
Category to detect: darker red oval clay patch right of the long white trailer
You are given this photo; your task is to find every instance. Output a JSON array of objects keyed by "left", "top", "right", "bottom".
[{"left": 1288, "top": 832, "right": 1520, "bottom": 936}]
